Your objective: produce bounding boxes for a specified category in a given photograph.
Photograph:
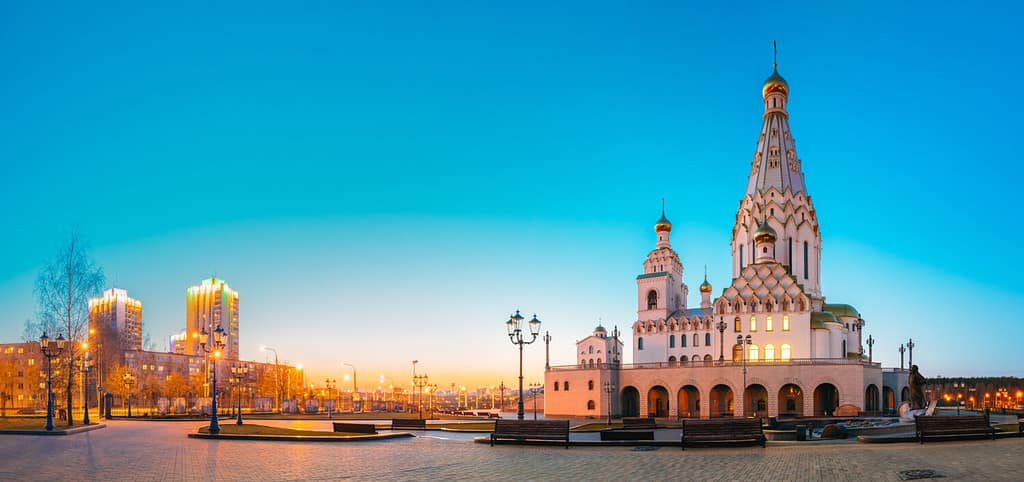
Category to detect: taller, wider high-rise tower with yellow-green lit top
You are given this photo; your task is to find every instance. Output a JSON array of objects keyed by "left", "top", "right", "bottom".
[{"left": 185, "top": 277, "right": 239, "bottom": 360}]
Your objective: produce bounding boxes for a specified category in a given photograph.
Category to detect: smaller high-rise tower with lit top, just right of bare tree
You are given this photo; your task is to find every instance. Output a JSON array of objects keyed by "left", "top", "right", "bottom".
[{"left": 89, "top": 288, "right": 142, "bottom": 350}]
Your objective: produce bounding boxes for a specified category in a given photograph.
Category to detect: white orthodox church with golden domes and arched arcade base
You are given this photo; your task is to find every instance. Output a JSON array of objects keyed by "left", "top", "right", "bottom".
[{"left": 545, "top": 62, "right": 908, "bottom": 419}]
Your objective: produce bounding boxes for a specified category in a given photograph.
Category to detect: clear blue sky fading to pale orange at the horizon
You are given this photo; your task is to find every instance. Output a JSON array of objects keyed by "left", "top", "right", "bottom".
[{"left": 0, "top": 1, "right": 1024, "bottom": 386}]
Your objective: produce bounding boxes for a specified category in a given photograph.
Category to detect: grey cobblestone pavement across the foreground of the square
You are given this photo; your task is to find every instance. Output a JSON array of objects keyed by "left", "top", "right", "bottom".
[{"left": 0, "top": 421, "right": 1024, "bottom": 481}]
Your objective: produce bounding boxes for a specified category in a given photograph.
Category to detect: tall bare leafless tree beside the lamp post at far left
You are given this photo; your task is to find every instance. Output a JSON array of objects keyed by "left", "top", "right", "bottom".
[{"left": 35, "top": 234, "right": 103, "bottom": 426}]
